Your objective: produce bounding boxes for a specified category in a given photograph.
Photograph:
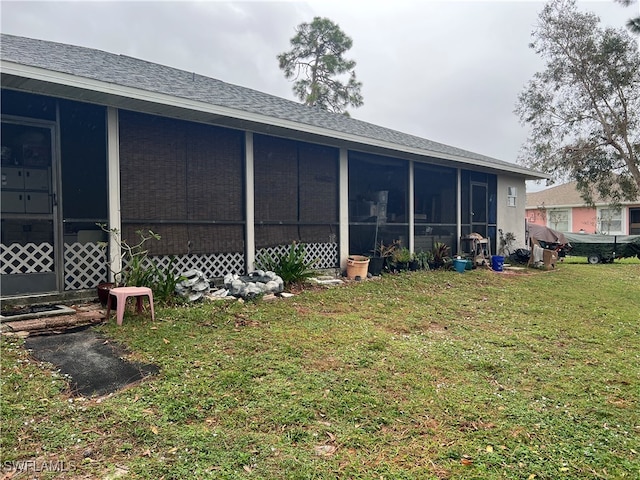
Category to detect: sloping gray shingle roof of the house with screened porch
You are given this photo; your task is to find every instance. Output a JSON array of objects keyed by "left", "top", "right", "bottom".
[{"left": 1, "top": 34, "right": 538, "bottom": 177}]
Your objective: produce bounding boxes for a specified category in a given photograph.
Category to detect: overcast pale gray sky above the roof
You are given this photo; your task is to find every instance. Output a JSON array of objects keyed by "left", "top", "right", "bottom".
[{"left": 0, "top": 0, "right": 639, "bottom": 189}]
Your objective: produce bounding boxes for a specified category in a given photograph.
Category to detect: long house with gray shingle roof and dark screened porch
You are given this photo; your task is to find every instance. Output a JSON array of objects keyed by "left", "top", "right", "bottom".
[{"left": 1, "top": 35, "right": 545, "bottom": 296}]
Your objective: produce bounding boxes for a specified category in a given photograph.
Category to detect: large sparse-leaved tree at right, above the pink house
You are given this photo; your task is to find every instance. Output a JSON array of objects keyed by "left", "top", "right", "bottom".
[{"left": 516, "top": 0, "right": 640, "bottom": 203}]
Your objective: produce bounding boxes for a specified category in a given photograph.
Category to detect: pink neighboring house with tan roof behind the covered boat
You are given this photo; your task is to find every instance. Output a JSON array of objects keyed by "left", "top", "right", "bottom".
[{"left": 526, "top": 182, "right": 640, "bottom": 235}]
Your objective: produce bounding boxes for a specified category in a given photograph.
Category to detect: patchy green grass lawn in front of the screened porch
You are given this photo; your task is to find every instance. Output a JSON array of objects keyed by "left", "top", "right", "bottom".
[{"left": 1, "top": 259, "right": 640, "bottom": 480}]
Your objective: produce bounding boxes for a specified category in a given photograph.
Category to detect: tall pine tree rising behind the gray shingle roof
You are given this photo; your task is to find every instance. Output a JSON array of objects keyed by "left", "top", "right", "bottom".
[{"left": 278, "top": 17, "right": 363, "bottom": 115}]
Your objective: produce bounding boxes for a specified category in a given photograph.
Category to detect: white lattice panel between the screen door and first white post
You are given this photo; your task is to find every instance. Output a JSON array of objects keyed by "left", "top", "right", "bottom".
[{"left": 64, "top": 243, "right": 107, "bottom": 290}]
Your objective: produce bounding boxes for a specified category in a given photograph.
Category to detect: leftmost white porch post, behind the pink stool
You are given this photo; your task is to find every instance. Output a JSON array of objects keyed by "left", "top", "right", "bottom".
[{"left": 107, "top": 107, "right": 122, "bottom": 282}]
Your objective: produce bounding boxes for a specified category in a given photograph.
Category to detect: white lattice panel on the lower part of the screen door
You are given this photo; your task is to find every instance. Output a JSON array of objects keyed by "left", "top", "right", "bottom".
[{"left": 0, "top": 243, "right": 54, "bottom": 275}]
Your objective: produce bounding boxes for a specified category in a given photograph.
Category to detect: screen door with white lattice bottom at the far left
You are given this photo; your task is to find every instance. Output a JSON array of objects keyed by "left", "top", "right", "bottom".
[{"left": 0, "top": 119, "right": 61, "bottom": 296}]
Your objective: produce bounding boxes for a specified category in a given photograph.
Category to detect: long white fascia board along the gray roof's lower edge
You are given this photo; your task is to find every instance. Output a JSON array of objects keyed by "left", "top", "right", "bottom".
[{"left": 0, "top": 60, "right": 549, "bottom": 179}]
